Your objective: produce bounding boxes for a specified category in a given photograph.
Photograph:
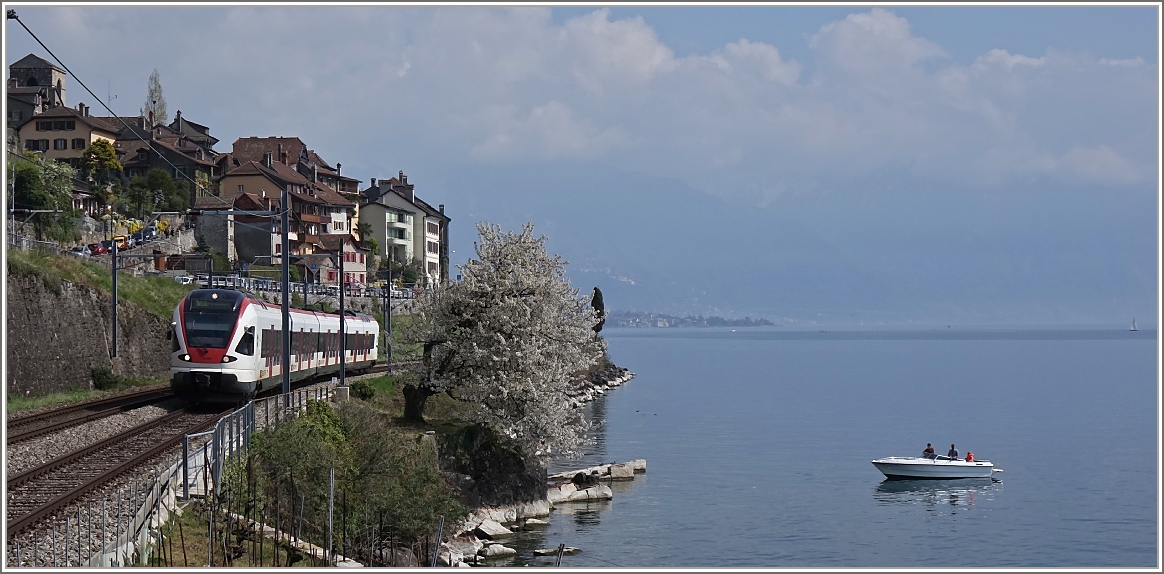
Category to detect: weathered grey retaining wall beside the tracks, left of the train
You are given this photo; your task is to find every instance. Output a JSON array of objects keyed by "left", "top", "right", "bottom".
[{"left": 5, "top": 276, "right": 170, "bottom": 396}]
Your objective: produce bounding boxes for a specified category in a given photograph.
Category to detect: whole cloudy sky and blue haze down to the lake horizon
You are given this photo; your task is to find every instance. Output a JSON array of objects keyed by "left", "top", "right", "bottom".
[{"left": 3, "top": 2, "right": 1161, "bottom": 327}]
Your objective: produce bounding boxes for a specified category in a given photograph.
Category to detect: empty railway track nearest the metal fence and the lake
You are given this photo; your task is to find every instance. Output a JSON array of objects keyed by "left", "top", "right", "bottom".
[{"left": 6, "top": 411, "right": 227, "bottom": 539}]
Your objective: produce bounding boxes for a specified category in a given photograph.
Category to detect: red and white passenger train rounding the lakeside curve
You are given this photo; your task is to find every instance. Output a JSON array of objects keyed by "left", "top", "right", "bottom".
[{"left": 169, "top": 289, "right": 379, "bottom": 403}]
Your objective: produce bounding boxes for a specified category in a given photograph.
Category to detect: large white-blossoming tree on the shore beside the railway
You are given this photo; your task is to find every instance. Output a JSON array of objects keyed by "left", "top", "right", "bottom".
[{"left": 404, "top": 218, "right": 605, "bottom": 462}]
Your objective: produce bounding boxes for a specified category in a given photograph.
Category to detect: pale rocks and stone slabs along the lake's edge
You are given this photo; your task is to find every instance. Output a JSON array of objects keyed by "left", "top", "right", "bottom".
[{"left": 437, "top": 366, "right": 646, "bottom": 567}]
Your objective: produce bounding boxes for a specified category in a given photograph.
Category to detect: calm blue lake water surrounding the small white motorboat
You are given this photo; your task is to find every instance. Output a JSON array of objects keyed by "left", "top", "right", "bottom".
[{"left": 497, "top": 327, "right": 1159, "bottom": 568}]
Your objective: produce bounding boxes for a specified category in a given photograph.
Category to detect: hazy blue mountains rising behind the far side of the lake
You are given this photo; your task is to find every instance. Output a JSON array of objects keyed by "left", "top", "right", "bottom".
[{"left": 426, "top": 158, "right": 1158, "bottom": 325}]
